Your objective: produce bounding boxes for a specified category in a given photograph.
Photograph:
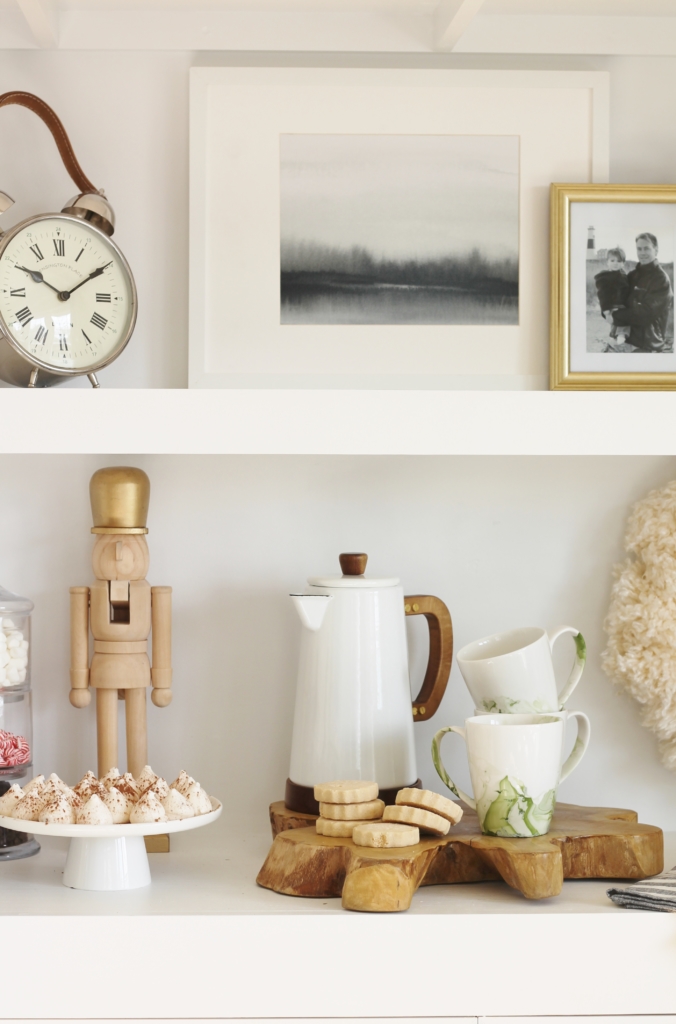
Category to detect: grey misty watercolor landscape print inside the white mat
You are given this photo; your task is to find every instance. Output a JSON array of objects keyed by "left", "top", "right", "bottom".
[{"left": 280, "top": 135, "right": 519, "bottom": 325}]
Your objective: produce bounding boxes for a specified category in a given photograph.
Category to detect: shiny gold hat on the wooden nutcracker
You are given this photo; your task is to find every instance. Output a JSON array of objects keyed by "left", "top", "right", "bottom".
[{"left": 89, "top": 466, "right": 151, "bottom": 534}]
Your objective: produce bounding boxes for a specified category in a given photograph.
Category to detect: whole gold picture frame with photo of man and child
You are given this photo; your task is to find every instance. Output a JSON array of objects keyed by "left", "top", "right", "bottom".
[{"left": 550, "top": 183, "right": 676, "bottom": 391}]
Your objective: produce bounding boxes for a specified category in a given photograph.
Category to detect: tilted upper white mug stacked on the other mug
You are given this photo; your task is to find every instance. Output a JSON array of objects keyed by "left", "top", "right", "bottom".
[{"left": 457, "top": 626, "right": 587, "bottom": 715}]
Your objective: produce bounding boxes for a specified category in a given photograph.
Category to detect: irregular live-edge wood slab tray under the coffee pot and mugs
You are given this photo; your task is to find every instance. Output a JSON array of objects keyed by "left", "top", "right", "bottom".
[{"left": 256, "top": 802, "right": 664, "bottom": 911}]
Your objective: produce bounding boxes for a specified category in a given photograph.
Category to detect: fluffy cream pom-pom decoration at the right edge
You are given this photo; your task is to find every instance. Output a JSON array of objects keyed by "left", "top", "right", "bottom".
[{"left": 602, "top": 480, "right": 676, "bottom": 770}]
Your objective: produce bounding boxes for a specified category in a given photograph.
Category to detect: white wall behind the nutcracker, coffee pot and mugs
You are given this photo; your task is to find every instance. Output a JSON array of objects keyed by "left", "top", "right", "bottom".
[{"left": 7, "top": 456, "right": 676, "bottom": 829}]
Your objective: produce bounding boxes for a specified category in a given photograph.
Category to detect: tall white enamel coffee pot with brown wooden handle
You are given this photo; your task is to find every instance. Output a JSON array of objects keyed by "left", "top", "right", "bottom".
[{"left": 286, "top": 554, "right": 453, "bottom": 813}]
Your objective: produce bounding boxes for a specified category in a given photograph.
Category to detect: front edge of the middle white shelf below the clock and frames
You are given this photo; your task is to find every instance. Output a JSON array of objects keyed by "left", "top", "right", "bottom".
[{"left": 0, "top": 389, "right": 676, "bottom": 455}]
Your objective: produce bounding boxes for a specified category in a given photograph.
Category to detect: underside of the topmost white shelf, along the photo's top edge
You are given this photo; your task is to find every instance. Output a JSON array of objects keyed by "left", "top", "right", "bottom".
[{"left": 0, "top": 0, "right": 676, "bottom": 55}]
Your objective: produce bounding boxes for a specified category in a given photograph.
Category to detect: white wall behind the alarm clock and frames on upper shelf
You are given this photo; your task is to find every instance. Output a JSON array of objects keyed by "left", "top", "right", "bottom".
[{"left": 0, "top": 50, "right": 676, "bottom": 387}]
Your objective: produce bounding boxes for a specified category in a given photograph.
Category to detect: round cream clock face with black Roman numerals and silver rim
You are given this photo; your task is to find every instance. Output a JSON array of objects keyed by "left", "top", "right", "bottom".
[{"left": 0, "top": 214, "right": 136, "bottom": 374}]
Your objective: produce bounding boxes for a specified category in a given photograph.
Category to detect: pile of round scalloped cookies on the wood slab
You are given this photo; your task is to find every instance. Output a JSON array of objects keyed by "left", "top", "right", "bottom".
[{"left": 314, "top": 779, "right": 462, "bottom": 849}]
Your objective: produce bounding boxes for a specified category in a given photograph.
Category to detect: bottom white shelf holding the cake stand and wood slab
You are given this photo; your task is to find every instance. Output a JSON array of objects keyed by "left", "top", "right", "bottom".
[{"left": 0, "top": 820, "right": 676, "bottom": 1018}]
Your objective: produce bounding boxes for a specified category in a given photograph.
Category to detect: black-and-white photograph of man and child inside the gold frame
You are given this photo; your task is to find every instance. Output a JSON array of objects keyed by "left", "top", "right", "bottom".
[{"left": 578, "top": 204, "right": 674, "bottom": 353}]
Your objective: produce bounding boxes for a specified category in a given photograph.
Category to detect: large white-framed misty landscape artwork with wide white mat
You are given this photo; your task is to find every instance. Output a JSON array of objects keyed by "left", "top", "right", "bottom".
[{"left": 189, "top": 68, "right": 607, "bottom": 388}]
